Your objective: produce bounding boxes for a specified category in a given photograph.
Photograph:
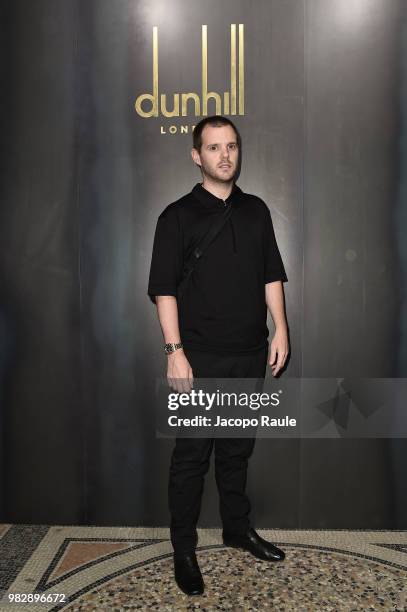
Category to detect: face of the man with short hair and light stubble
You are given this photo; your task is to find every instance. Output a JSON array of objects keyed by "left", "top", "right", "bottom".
[{"left": 191, "top": 125, "right": 239, "bottom": 183}]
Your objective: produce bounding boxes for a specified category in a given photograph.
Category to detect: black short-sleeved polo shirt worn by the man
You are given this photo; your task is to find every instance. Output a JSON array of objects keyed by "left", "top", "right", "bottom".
[{"left": 148, "top": 183, "right": 287, "bottom": 354}]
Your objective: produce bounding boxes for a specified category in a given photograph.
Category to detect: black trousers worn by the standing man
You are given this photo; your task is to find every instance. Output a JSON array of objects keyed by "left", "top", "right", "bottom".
[{"left": 168, "top": 347, "right": 268, "bottom": 551}]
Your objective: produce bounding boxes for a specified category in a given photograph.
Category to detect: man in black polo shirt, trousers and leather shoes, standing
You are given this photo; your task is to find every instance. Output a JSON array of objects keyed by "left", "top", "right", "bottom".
[{"left": 148, "top": 115, "right": 288, "bottom": 595}]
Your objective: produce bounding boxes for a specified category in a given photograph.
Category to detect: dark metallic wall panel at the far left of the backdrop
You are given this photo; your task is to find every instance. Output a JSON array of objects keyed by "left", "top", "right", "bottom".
[{"left": 0, "top": 1, "right": 85, "bottom": 524}]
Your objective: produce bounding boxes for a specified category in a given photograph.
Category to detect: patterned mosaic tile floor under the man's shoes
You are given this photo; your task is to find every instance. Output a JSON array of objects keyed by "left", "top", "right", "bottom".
[{"left": 0, "top": 525, "right": 407, "bottom": 612}]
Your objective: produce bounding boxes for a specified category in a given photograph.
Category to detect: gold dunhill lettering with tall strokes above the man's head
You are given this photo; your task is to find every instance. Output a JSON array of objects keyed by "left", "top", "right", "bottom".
[{"left": 134, "top": 23, "right": 244, "bottom": 117}]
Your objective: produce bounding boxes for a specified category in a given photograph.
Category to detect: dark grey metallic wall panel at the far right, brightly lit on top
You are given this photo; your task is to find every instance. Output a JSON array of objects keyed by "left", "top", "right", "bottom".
[{"left": 300, "top": 0, "right": 407, "bottom": 529}]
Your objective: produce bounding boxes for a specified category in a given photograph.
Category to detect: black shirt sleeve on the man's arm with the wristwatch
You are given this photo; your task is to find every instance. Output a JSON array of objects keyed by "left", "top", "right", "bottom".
[{"left": 147, "top": 207, "right": 182, "bottom": 304}]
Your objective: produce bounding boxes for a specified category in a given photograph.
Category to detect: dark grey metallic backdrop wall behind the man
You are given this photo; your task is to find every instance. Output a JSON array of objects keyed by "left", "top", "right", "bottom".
[{"left": 0, "top": 0, "right": 407, "bottom": 528}]
